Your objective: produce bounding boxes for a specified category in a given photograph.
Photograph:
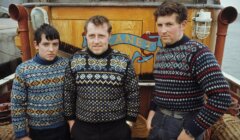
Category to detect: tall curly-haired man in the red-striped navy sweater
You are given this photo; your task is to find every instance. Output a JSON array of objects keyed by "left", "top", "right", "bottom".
[{"left": 148, "top": 2, "right": 231, "bottom": 140}]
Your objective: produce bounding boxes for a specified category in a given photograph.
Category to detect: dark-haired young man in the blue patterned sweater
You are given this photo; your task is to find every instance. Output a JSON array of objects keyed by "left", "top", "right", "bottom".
[{"left": 11, "top": 24, "right": 70, "bottom": 140}]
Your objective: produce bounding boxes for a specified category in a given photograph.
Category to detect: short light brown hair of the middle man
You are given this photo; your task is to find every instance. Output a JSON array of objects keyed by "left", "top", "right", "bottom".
[{"left": 84, "top": 15, "right": 112, "bottom": 33}]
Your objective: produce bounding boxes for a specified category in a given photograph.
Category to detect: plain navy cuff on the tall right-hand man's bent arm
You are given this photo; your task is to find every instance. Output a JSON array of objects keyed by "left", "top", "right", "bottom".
[{"left": 184, "top": 120, "right": 205, "bottom": 138}]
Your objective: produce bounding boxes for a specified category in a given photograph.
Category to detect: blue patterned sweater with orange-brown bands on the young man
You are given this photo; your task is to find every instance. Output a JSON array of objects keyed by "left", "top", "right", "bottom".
[{"left": 11, "top": 55, "right": 68, "bottom": 138}]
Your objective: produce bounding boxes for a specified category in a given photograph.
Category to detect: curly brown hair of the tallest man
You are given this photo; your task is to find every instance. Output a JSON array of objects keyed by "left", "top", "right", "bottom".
[{"left": 154, "top": 1, "right": 187, "bottom": 23}]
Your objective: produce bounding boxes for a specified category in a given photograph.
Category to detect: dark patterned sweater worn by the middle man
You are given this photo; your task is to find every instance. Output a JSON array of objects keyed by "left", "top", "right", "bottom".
[{"left": 64, "top": 48, "right": 139, "bottom": 123}]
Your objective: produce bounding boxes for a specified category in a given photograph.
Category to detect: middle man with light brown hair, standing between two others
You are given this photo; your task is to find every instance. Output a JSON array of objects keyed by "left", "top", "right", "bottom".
[{"left": 64, "top": 16, "right": 139, "bottom": 140}]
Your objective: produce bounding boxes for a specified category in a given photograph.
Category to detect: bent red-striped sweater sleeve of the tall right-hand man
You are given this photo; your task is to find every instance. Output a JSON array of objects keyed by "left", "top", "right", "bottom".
[{"left": 184, "top": 47, "right": 231, "bottom": 137}]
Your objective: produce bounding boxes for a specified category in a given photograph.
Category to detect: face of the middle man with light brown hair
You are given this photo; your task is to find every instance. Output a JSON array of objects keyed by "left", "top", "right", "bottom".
[{"left": 86, "top": 22, "right": 111, "bottom": 55}]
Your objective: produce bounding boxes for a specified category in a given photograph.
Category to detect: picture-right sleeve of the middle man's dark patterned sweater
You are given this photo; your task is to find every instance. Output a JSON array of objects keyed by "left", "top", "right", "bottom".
[{"left": 124, "top": 61, "right": 140, "bottom": 122}]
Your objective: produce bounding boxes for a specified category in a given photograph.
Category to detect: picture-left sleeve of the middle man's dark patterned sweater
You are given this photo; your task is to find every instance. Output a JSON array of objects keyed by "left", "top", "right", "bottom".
[{"left": 64, "top": 61, "right": 76, "bottom": 120}]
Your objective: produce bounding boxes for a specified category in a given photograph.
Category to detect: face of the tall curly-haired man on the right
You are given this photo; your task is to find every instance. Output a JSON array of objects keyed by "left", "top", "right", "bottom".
[{"left": 156, "top": 13, "right": 186, "bottom": 45}]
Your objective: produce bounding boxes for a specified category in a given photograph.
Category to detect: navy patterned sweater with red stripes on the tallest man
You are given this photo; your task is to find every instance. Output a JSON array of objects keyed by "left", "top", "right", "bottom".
[{"left": 153, "top": 36, "right": 231, "bottom": 136}]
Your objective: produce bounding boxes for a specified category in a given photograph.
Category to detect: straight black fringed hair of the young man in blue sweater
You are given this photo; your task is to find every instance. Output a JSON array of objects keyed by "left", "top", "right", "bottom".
[{"left": 34, "top": 23, "right": 60, "bottom": 45}]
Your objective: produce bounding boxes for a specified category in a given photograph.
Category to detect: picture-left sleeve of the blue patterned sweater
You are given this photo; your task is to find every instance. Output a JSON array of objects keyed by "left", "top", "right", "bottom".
[{"left": 11, "top": 65, "right": 28, "bottom": 138}]
